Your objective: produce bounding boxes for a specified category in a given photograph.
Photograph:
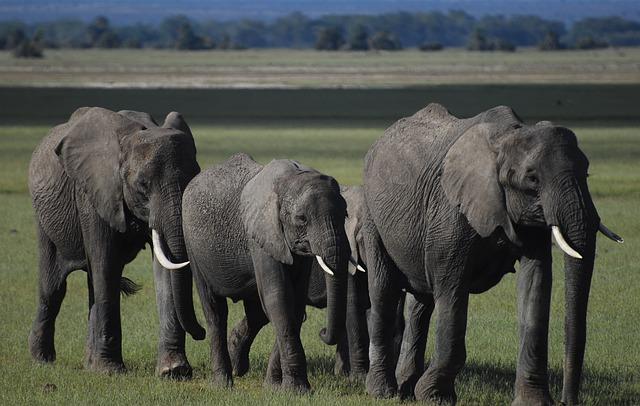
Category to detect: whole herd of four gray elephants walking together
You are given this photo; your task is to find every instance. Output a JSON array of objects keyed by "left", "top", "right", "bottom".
[{"left": 29, "top": 104, "right": 622, "bottom": 404}]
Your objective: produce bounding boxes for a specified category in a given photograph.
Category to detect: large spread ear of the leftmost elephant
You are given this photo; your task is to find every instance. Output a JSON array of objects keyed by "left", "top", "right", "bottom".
[{"left": 55, "top": 107, "right": 142, "bottom": 232}]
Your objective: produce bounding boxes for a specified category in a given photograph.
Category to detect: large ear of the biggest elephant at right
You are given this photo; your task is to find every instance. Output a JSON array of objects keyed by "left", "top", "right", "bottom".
[{"left": 440, "top": 123, "right": 520, "bottom": 245}]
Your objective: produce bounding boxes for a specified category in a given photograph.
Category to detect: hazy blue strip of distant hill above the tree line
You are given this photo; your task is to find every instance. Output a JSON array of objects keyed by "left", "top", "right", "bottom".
[{"left": 0, "top": 0, "right": 640, "bottom": 24}]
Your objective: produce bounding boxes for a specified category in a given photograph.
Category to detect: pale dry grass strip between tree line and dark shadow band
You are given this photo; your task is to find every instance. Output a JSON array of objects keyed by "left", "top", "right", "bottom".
[{"left": 0, "top": 48, "right": 640, "bottom": 88}]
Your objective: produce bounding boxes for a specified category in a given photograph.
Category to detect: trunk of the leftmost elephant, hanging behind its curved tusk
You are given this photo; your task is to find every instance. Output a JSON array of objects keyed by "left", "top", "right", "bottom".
[{"left": 158, "top": 192, "right": 206, "bottom": 340}]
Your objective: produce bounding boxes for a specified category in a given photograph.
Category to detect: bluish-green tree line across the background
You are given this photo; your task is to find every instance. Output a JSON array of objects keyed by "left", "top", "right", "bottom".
[{"left": 0, "top": 11, "right": 640, "bottom": 56}]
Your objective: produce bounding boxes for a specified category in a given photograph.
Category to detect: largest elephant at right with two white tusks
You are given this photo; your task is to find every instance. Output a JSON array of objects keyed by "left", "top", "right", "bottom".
[{"left": 364, "top": 104, "right": 619, "bottom": 404}]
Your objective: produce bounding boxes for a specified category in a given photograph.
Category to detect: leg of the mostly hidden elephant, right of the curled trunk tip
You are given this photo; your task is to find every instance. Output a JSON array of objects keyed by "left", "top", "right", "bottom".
[{"left": 347, "top": 272, "right": 369, "bottom": 381}]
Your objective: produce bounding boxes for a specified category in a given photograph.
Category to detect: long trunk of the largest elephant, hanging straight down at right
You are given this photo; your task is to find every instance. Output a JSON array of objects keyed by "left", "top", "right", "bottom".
[{"left": 554, "top": 177, "right": 600, "bottom": 405}]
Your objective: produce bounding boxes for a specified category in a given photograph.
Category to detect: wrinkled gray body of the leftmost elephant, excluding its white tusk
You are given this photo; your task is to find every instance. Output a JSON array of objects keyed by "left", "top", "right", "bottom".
[{"left": 29, "top": 107, "right": 205, "bottom": 376}]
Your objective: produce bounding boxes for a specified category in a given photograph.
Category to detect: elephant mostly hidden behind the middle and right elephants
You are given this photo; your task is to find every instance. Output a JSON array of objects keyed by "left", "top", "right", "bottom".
[{"left": 229, "top": 186, "right": 390, "bottom": 378}]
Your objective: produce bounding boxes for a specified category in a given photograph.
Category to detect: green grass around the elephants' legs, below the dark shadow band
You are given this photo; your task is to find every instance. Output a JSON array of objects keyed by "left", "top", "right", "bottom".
[{"left": 0, "top": 121, "right": 640, "bottom": 405}]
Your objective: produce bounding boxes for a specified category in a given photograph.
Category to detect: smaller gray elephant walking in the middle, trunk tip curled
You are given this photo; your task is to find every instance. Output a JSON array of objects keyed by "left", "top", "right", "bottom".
[{"left": 183, "top": 154, "right": 350, "bottom": 392}]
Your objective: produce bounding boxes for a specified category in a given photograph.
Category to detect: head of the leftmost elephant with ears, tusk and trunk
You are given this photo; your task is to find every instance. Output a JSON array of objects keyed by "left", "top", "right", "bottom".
[{"left": 55, "top": 107, "right": 204, "bottom": 339}]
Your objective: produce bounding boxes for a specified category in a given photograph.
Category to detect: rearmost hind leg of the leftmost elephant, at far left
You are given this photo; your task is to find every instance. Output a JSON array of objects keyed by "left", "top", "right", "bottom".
[{"left": 29, "top": 226, "right": 67, "bottom": 362}]
